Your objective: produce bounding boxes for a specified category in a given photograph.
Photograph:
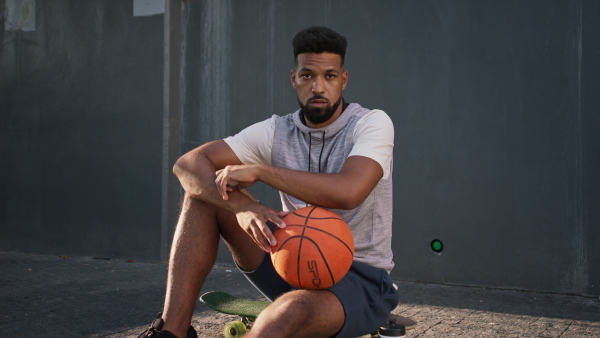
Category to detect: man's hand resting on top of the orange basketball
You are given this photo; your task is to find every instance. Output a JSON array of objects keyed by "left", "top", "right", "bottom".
[{"left": 235, "top": 202, "right": 289, "bottom": 252}]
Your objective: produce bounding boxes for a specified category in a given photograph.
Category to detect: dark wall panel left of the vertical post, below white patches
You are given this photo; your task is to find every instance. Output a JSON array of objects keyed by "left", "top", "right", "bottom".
[{"left": 0, "top": 0, "right": 164, "bottom": 260}]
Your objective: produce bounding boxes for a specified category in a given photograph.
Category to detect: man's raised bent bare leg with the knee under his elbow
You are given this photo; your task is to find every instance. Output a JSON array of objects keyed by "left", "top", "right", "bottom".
[{"left": 162, "top": 194, "right": 264, "bottom": 337}]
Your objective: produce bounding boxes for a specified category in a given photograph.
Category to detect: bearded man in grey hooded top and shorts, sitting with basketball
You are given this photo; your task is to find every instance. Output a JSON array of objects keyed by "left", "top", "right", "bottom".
[{"left": 140, "top": 27, "right": 398, "bottom": 338}]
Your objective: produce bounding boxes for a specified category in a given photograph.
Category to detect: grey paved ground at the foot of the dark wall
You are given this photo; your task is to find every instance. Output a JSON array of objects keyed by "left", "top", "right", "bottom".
[{"left": 0, "top": 253, "right": 600, "bottom": 337}]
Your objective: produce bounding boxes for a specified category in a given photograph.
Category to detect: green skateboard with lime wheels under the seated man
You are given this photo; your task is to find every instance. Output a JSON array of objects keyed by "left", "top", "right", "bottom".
[{"left": 200, "top": 291, "right": 417, "bottom": 338}]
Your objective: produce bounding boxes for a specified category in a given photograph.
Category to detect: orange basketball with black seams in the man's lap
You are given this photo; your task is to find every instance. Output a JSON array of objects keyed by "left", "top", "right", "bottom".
[{"left": 271, "top": 207, "right": 354, "bottom": 289}]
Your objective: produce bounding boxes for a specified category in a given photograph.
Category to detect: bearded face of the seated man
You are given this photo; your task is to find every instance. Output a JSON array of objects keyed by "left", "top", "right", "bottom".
[{"left": 291, "top": 53, "right": 348, "bottom": 128}]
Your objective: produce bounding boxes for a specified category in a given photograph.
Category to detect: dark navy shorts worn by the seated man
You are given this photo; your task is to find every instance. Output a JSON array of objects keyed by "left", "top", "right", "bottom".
[{"left": 240, "top": 254, "right": 400, "bottom": 337}]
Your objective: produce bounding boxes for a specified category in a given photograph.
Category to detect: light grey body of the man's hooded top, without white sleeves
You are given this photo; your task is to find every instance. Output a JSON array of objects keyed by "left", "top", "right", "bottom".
[{"left": 271, "top": 103, "right": 394, "bottom": 273}]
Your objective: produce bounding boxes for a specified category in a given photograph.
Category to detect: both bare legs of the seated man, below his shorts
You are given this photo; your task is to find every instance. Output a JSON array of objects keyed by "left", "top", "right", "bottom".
[{"left": 162, "top": 194, "right": 344, "bottom": 338}]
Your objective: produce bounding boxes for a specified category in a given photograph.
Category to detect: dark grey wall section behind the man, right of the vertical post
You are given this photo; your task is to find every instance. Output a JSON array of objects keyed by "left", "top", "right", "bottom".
[{"left": 184, "top": 0, "right": 600, "bottom": 295}]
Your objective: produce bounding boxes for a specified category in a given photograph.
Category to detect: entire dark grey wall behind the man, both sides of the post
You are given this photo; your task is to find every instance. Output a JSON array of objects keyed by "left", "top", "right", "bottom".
[{"left": 0, "top": 0, "right": 600, "bottom": 296}]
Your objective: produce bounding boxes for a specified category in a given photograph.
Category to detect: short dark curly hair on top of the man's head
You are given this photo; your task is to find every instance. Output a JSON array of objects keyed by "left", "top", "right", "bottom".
[{"left": 292, "top": 26, "right": 348, "bottom": 66}]
